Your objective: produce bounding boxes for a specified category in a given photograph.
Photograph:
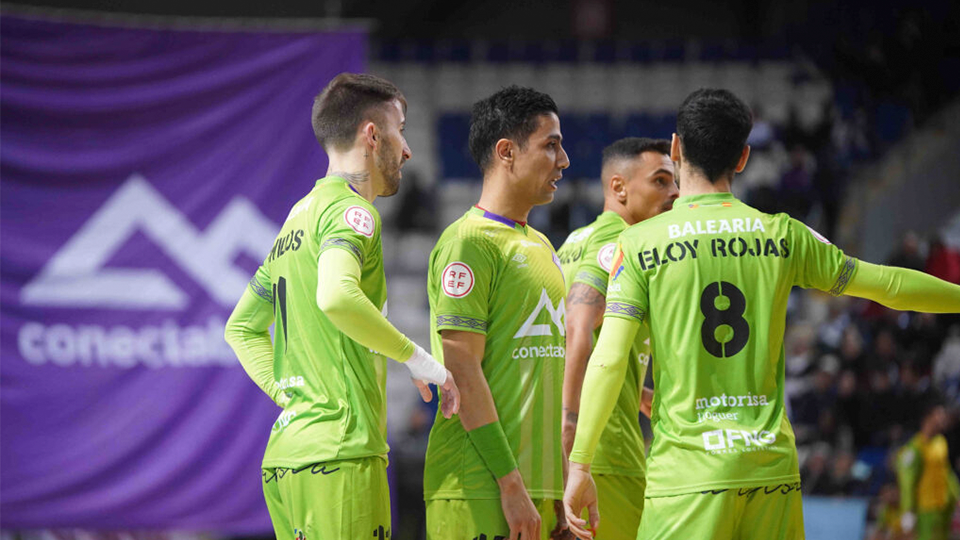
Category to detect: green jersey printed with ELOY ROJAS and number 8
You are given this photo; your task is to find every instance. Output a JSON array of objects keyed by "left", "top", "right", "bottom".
[{"left": 605, "top": 193, "right": 857, "bottom": 497}]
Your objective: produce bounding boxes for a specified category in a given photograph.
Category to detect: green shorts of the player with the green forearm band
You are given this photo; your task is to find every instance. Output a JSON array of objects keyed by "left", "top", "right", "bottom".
[{"left": 427, "top": 499, "right": 557, "bottom": 540}]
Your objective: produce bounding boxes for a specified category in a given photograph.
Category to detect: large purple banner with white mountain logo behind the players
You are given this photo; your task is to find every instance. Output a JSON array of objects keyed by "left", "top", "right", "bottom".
[{"left": 0, "top": 16, "right": 366, "bottom": 534}]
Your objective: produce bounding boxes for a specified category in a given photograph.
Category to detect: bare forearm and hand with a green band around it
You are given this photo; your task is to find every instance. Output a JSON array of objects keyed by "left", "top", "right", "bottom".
[{"left": 440, "top": 330, "right": 540, "bottom": 539}]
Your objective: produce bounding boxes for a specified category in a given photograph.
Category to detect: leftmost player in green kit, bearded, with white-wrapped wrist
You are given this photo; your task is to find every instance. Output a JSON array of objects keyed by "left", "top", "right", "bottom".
[{"left": 226, "top": 73, "right": 459, "bottom": 540}]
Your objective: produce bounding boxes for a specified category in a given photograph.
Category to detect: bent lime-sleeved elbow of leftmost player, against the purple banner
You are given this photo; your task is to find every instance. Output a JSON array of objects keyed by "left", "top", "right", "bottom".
[{"left": 224, "top": 287, "right": 286, "bottom": 407}]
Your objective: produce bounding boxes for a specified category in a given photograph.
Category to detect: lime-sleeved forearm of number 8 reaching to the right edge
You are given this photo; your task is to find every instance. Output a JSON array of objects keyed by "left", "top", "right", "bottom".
[{"left": 844, "top": 261, "right": 960, "bottom": 313}]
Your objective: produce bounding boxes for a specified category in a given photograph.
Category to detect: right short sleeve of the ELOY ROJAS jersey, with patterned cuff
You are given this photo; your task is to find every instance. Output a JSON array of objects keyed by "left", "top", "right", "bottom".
[{"left": 790, "top": 218, "right": 857, "bottom": 296}]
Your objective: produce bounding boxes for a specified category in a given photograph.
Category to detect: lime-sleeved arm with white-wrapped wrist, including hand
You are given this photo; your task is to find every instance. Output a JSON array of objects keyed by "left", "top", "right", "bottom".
[{"left": 317, "top": 249, "right": 460, "bottom": 418}]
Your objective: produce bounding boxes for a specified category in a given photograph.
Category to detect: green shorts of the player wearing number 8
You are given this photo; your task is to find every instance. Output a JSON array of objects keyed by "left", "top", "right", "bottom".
[{"left": 636, "top": 483, "right": 804, "bottom": 540}]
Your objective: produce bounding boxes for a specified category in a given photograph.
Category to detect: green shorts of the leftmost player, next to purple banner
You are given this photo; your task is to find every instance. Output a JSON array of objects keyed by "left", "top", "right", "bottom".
[{"left": 263, "top": 457, "right": 390, "bottom": 540}]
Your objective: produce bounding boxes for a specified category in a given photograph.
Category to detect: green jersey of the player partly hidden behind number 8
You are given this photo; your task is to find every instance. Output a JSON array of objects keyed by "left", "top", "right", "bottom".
[{"left": 557, "top": 211, "right": 650, "bottom": 476}]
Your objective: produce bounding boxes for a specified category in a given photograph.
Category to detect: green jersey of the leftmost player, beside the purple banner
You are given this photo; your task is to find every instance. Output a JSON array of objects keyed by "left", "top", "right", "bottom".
[{"left": 249, "top": 177, "right": 388, "bottom": 468}]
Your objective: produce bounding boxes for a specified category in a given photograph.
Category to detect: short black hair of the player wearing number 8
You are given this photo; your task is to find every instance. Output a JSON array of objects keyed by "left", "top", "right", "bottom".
[{"left": 677, "top": 88, "right": 753, "bottom": 182}]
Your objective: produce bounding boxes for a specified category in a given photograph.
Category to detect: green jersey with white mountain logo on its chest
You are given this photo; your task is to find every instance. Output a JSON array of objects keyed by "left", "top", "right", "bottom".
[{"left": 424, "top": 207, "right": 565, "bottom": 500}]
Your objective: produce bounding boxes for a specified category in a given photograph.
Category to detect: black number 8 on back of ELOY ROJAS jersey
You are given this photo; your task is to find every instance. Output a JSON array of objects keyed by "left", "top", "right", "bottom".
[{"left": 700, "top": 281, "right": 750, "bottom": 358}]
